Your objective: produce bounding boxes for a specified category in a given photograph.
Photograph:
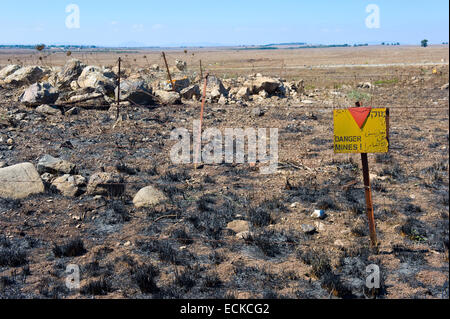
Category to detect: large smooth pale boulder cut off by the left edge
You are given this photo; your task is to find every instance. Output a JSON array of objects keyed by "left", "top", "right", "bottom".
[{"left": 0, "top": 163, "right": 44, "bottom": 199}]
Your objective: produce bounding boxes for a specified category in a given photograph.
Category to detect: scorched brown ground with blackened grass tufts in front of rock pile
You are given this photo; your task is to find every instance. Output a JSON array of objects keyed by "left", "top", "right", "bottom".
[{"left": 0, "top": 68, "right": 449, "bottom": 298}]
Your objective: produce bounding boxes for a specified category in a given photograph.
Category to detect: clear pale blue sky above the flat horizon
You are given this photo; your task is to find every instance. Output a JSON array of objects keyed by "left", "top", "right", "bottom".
[{"left": 0, "top": 0, "right": 449, "bottom": 46}]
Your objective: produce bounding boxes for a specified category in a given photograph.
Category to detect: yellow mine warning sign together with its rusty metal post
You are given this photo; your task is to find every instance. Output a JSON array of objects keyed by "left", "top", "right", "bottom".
[{"left": 334, "top": 103, "right": 389, "bottom": 246}]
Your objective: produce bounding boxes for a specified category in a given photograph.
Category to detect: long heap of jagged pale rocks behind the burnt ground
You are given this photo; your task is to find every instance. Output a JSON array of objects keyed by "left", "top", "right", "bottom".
[{"left": 0, "top": 59, "right": 314, "bottom": 110}]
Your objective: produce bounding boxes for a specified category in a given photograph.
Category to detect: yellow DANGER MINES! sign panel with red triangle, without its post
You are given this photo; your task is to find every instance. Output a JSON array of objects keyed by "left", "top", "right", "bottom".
[{"left": 334, "top": 108, "right": 389, "bottom": 153}]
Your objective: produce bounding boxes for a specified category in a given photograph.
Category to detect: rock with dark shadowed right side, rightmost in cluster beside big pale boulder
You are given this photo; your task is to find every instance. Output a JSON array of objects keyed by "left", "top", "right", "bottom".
[{"left": 87, "top": 172, "right": 125, "bottom": 196}]
